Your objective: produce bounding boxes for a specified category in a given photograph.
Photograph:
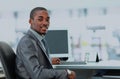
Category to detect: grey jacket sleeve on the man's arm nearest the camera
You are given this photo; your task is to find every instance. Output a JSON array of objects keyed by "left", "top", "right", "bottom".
[{"left": 17, "top": 39, "right": 67, "bottom": 79}]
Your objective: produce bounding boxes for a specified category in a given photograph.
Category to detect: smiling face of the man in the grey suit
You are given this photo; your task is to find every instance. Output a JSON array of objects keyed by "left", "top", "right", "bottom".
[{"left": 29, "top": 10, "right": 50, "bottom": 35}]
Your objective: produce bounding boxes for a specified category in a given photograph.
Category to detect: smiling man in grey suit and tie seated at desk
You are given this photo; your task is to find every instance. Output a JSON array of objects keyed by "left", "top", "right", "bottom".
[{"left": 16, "top": 7, "right": 75, "bottom": 79}]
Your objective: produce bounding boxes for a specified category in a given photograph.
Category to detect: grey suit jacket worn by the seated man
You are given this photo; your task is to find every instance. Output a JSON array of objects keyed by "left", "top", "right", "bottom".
[{"left": 16, "top": 31, "right": 68, "bottom": 79}]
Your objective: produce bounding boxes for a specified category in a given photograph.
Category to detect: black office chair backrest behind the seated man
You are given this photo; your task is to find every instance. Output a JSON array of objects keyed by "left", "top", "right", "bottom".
[{"left": 0, "top": 42, "right": 16, "bottom": 79}]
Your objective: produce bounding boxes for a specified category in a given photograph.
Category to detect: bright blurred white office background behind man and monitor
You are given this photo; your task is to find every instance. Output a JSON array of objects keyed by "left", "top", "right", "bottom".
[{"left": 0, "top": 0, "right": 120, "bottom": 61}]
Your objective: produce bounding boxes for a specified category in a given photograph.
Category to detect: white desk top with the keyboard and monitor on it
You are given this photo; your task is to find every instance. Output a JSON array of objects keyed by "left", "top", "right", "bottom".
[{"left": 53, "top": 60, "right": 120, "bottom": 69}]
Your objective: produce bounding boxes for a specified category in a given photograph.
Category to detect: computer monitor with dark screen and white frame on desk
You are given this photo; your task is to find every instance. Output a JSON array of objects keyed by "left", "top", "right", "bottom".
[{"left": 45, "top": 29, "right": 70, "bottom": 60}]
